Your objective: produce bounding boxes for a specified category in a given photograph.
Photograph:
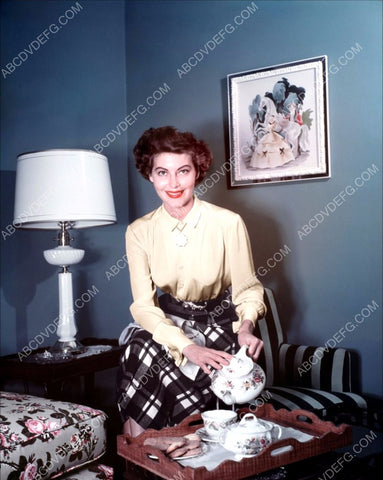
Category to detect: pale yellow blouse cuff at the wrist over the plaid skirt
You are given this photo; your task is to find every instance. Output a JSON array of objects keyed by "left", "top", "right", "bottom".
[{"left": 153, "top": 322, "right": 194, "bottom": 367}]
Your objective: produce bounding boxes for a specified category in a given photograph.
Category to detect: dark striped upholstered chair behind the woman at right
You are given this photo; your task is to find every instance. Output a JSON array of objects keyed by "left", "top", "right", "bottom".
[{"left": 253, "top": 288, "right": 382, "bottom": 428}]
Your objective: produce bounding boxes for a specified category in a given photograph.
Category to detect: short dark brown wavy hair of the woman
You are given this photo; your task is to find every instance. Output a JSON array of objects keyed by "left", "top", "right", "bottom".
[{"left": 133, "top": 126, "right": 213, "bottom": 185}]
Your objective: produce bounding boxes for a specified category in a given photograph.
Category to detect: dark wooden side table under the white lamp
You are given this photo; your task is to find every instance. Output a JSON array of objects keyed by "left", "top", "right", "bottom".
[{"left": 0, "top": 338, "right": 123, "bottom": 402}]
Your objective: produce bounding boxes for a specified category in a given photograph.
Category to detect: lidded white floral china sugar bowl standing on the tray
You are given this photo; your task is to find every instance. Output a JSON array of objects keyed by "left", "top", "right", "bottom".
[{"left": 219, "top": 413, "right": 282, "bottom": 455}]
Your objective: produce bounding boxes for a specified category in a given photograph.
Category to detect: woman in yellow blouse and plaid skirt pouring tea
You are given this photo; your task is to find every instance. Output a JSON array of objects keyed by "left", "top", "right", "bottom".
[{"left": 118, "top": 127, "right": 265, "bottom": 436}]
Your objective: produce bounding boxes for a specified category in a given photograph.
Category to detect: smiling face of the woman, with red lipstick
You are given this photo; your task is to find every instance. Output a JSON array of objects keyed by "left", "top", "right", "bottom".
[{"left": 149, "top": 152, "right": 197, "bottom": 220}]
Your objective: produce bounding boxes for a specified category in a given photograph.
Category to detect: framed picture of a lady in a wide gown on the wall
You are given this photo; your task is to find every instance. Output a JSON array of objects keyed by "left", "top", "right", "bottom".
[{"left": 227, "top": 56, "right": 330, "bottom": 187}]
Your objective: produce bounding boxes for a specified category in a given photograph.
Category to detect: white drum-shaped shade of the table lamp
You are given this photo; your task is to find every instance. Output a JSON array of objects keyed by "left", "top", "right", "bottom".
[{"left": 13, "top": 149, "right": 116, "bottom": 229}]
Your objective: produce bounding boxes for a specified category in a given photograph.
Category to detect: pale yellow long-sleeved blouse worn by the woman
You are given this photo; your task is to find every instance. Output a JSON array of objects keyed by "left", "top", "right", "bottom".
[{"left": 126, "top": 198, "right": 266, "bottom": 365}]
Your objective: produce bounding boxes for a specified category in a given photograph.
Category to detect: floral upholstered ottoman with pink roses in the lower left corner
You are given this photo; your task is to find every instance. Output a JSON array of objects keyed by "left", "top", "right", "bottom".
[{"left": 0, "top": 392, "right": 113, "bottom": 480}]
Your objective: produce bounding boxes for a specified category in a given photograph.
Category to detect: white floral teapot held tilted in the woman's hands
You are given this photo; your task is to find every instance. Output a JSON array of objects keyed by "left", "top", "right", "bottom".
[{"left": 211, "top": 345, "right": 266, "bottom": 405}]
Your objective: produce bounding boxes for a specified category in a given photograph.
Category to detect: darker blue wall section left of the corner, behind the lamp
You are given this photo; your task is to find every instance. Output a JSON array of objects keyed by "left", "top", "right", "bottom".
[{"left": 1, "top": 0, "right": 131, "bottom": 354}]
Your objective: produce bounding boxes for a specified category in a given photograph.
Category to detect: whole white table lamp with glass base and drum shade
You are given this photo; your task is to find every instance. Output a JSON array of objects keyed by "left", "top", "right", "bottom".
[{"left": 14, "top": 149, "right": 116, "bottom": 355}]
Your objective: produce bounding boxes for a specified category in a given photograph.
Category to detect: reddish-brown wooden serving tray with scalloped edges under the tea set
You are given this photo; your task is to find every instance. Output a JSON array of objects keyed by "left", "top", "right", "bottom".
[{"left": 117, "top": 404, "right": 352, "bottom": 480}]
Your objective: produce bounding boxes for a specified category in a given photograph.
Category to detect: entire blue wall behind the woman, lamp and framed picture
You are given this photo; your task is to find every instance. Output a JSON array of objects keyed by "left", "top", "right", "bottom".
[{"left": 1, "top": 1, "right": 382, "bottom": 395}]
